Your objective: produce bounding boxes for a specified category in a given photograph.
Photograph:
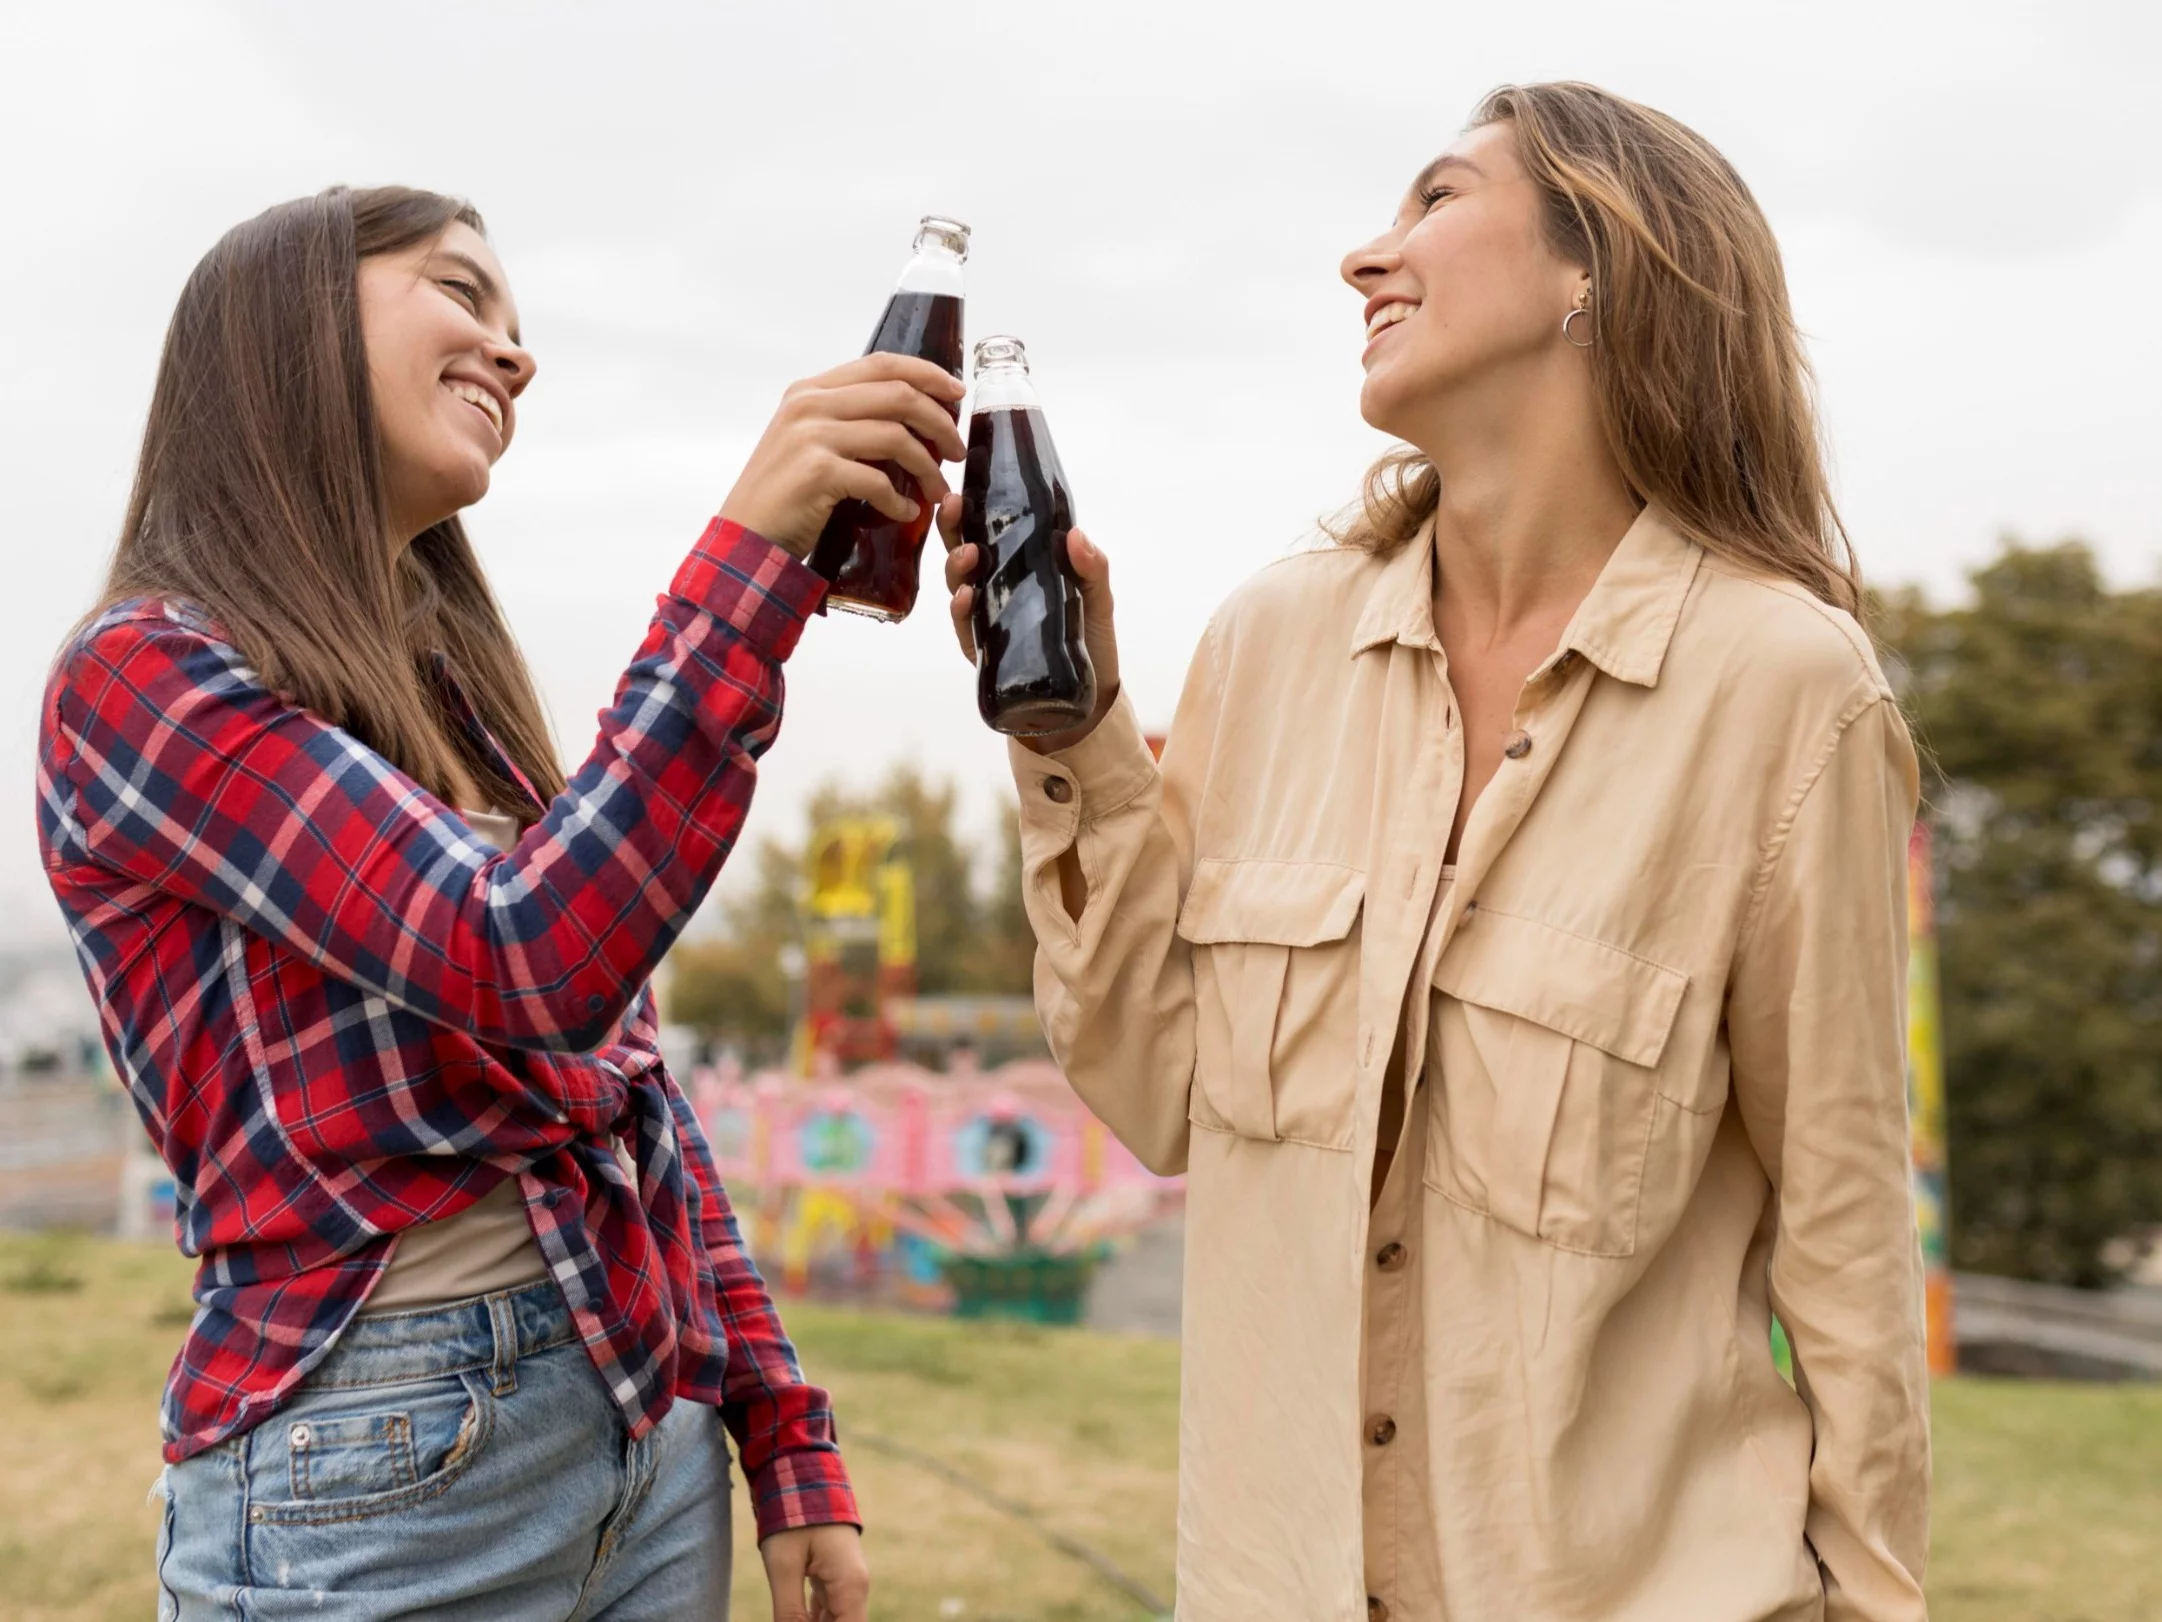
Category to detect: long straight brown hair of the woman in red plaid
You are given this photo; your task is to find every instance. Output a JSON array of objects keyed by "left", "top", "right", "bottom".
[{"left": 102, "top": 186, "right": 564, "bottom": 820}]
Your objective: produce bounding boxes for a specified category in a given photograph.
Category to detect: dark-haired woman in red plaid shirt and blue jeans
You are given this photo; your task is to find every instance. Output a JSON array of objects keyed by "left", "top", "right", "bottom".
[{"left": 39, "top": 188, "right": 964, "bottom": 1622}]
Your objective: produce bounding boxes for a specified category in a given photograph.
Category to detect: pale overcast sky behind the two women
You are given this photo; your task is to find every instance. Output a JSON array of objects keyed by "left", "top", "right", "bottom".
[{"left": 0, "top": 0, "right": 2162, "bottom": 960}]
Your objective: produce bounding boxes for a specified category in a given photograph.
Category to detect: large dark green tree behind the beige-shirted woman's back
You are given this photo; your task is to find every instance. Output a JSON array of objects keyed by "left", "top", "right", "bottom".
[{"left": 1881, "top": 543, "right": 2162, "bottom": 1285}]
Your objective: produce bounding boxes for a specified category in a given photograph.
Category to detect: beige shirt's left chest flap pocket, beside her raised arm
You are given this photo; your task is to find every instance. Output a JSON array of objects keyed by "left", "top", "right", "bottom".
[{"left": 1178, "top": 859, "right": 1366, "bottom": 1148}]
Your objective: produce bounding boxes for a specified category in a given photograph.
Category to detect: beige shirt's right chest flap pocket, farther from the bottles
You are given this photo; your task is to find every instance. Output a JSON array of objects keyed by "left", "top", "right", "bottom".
[{"left": 1425, "top": 910, "right": 1689, "bottom": 1257}]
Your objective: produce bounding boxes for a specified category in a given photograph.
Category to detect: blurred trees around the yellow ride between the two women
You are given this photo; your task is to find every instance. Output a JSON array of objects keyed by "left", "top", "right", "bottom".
[{"left": 666, "top": 766, "right": 1036, "bottom": 1058}]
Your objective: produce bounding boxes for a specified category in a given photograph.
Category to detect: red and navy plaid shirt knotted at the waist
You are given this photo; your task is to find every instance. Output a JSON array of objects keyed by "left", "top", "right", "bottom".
[{"left": 37, "top": 519, "right": 858, "bottom": 1535}]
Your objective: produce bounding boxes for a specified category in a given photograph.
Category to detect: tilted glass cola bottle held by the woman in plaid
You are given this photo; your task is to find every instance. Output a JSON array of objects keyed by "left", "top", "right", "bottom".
[{"left": 811, "top": 214, "right": 969, "bottom": 621}]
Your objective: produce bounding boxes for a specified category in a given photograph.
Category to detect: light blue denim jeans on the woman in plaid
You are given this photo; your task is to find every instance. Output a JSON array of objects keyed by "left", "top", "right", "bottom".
[{"left": 158, "top": 1282, "right": 729, "bottom": 1622}]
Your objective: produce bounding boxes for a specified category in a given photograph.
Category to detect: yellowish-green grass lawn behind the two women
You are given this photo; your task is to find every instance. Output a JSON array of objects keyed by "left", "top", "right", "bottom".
[{"left": 0, "top": 1235, "right": 2162, "bottom": 1622}]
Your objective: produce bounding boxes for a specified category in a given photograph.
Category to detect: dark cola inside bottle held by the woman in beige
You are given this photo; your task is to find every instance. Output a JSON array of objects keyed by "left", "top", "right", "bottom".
[{"left": 960, "top": 409, "right": 1096, "bottom": 737}]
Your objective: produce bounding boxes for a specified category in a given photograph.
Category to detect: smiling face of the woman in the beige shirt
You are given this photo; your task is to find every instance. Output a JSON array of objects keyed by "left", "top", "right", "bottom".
[{"left": 1343, "top": 123, "right": 1589, "bottom": 443}]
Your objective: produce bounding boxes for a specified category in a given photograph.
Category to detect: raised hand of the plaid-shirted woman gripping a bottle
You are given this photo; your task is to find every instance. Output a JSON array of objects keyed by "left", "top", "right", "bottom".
[{"left": 720, "top": 355, "right": 969, "bottom": 558}]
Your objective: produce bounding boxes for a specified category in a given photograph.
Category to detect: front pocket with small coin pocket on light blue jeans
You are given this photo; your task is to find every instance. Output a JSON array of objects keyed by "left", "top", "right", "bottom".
[{"left": 249, "top": 1373, "right": 495, "bottom": 1525}]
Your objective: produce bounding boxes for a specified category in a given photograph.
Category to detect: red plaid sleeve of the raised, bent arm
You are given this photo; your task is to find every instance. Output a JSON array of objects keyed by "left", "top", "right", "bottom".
[{"left": 39, "top": 519, "right": 824, "bottom": 1051}]
